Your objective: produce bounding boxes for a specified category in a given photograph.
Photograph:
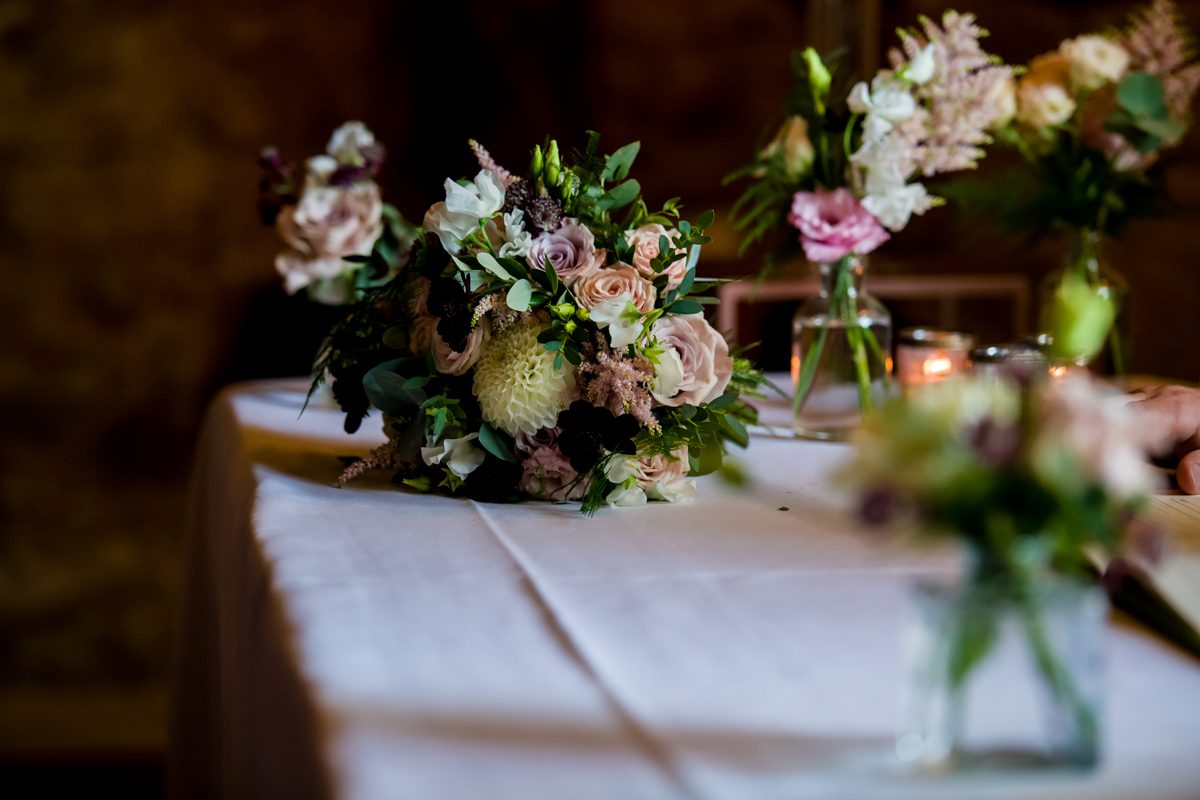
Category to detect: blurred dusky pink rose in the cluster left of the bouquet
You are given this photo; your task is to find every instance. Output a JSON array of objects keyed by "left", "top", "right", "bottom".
[{"left": 275, "top": 179, "right": 383, "bottom": 294}]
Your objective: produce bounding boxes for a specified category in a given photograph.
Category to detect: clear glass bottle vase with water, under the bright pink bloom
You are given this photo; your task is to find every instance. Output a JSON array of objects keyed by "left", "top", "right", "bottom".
[{"left": 792, "top": 255, "right": 892, "bottom": 440}]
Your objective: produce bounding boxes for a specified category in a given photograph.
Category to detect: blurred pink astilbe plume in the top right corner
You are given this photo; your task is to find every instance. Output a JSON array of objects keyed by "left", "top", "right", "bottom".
[{"left": 1120, "top": 0, "right": 1200, "bottom": 121}]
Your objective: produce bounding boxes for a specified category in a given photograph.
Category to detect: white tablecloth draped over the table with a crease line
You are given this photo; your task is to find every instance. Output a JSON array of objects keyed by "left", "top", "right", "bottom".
[{"left": 172, "top": 381, "right": 1200, "bottom": 800}]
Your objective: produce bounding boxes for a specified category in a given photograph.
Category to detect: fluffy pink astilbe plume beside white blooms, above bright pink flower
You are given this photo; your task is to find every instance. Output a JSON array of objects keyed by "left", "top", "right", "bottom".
[{"left": 889, "top": 11, "right": 1013, "bottom": 176}]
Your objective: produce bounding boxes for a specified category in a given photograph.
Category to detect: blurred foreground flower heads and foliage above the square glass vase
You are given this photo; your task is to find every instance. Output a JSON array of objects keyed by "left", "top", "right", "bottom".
[{"left": 844, "top": 375, "right": 1154, "bottom": 563}]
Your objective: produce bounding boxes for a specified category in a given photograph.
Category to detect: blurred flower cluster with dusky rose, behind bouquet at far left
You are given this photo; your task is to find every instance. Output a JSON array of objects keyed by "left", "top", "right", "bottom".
[{"left": 258, "top": 122, "right": 414, "bottom": 306}]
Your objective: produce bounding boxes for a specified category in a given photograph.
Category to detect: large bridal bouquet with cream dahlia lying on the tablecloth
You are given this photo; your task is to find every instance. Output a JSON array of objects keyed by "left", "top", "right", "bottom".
[{"left": 317, "top": 133, "right": 762, "bottom": 513}]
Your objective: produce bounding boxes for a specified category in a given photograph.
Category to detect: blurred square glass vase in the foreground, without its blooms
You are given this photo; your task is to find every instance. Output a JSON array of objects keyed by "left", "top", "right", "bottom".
[{"left": 896, "top": 576, "right": 1108, "bottom": 772}]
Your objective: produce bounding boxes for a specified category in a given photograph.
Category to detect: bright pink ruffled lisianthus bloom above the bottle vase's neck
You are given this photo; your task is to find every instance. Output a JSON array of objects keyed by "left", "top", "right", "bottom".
[{"left": 787, "top": 188, "right": 889, "bottom": 264}]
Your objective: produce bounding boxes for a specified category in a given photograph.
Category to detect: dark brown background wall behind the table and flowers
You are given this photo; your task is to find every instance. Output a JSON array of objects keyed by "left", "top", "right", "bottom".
[{"left": 0, "top": 0, "right": 1200, "bottom": 777}]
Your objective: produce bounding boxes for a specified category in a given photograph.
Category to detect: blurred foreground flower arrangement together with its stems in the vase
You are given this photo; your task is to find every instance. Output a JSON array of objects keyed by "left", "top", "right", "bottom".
[{"left": 841, "top": 377, "right": 1154, "bottom": 765}]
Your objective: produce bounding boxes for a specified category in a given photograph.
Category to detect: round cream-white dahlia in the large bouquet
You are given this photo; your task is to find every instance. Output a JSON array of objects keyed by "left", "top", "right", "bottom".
[{"left": 474, "top": 315, "right": 576, "bottom": 437}]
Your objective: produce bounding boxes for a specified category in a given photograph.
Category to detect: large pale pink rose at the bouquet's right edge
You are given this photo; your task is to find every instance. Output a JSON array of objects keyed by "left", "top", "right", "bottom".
[{"left": 650, "top": 314, "right": 733, "bottom": 405}]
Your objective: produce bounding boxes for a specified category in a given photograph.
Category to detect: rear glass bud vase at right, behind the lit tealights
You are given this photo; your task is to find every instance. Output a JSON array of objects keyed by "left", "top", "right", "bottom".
[{"left": 1039, "top": 228, "right": 1129, "bottom": 378}]
